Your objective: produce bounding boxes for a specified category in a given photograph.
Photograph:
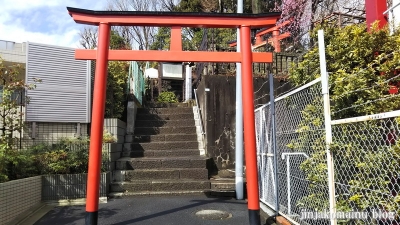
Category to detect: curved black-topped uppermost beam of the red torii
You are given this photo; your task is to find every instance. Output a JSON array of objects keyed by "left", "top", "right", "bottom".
[{"left": 67, "top": 7, "right": 281, "bottom": 28}]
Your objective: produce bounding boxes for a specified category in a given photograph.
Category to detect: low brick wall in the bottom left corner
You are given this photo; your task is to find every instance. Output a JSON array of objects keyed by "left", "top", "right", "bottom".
[{"left": 0, "top": 176, "right": 42, "bottom": 224}]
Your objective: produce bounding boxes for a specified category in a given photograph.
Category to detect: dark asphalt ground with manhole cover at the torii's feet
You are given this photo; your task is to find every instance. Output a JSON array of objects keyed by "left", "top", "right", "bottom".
[{"left": 35, "top": 195, "right": 253, "bottom": 225}]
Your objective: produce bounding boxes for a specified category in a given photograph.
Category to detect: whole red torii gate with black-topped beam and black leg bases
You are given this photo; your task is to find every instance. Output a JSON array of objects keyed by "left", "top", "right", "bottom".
[{"left": 67, "top": 7, "right": 280, "bottom": 225}]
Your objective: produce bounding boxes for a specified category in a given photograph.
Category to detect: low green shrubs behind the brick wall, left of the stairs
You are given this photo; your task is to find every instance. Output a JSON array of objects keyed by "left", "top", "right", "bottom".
[{"left": 0, "top": 132, "right": 115, "bottom": 183}]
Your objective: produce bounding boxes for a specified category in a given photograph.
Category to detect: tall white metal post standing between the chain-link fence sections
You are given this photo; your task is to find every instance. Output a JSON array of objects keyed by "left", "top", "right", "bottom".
[{"left": 318, "top": 30, "right": 337, "bottom": 225}]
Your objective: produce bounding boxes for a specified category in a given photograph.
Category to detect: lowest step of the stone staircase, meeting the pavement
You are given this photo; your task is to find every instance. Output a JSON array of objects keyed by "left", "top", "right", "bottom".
[{"left": 111, "top": 180, "right": 210, "bottom": 193}]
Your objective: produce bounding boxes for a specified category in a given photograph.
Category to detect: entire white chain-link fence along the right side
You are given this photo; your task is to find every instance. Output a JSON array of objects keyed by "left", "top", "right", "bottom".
[{"left": 255, "top": 76, "right": 400, "bottom": 225}]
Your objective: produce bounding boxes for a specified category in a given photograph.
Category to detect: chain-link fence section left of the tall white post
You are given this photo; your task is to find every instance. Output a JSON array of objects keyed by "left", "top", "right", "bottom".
[{"left": 256, "top": 80, "right": 329, "bottom": 224}]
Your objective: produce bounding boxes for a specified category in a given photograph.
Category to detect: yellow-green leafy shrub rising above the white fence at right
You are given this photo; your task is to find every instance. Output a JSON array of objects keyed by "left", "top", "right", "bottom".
[{"left": 289, "top": 24, "right": 400, "bottom": 119}]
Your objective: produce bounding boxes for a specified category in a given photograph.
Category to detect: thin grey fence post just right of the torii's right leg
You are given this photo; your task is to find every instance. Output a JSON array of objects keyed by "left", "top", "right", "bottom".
[{"left": 269, "top": 73, "right": 279, "bottom": 216}]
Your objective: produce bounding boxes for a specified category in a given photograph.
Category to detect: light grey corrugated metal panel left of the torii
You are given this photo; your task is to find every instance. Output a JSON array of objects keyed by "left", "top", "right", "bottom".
[{"left": 26, "top": 43, "right": 91, "bottom": 123}]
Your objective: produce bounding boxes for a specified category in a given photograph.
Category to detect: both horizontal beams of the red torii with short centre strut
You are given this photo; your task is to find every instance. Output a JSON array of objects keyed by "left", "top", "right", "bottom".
[{"left": 67, "top": 7, "right": 280, "bottom": 63}]
